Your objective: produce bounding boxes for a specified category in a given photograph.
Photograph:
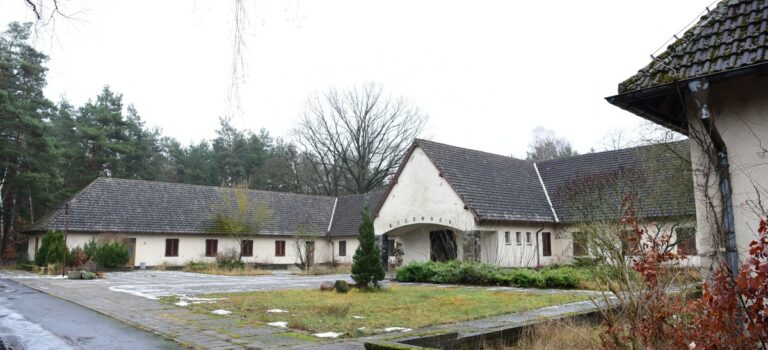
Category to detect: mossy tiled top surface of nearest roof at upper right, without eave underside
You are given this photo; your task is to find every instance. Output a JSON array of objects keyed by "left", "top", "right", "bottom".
[{"left": 619, "top": 0, "right": 768, "bottom": 93}]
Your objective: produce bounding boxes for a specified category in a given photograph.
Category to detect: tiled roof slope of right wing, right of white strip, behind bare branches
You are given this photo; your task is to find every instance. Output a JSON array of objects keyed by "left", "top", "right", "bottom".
[{"left": 537, "top": 141, "right": 695, "bottom": 222}]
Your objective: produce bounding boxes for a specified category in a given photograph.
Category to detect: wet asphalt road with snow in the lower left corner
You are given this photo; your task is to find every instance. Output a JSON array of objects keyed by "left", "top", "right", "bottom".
[{"left": 0, "top": 278, "right": 181, "bottom": 350}]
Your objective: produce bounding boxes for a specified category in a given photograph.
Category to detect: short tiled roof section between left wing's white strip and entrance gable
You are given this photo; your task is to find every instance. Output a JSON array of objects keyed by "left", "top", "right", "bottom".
[{"left": 328, "top": 192, "right": 383, "bottom": 235}]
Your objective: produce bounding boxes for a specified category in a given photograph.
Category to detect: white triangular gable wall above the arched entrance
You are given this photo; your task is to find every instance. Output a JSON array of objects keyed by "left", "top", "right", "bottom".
[{"left": 373, "top": 147, "right": 475, "bottom": 235}]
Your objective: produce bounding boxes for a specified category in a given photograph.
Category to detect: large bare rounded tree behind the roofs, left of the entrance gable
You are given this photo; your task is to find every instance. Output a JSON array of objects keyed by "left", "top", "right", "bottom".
[{"left": 293, "top": 84, "right": 426, "bottom": 195}]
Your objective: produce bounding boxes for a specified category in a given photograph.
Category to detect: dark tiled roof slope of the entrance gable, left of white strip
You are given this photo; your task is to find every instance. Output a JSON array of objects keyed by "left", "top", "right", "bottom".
[{"left": 415, "top": 140, "right": 554, "bottom": 222}]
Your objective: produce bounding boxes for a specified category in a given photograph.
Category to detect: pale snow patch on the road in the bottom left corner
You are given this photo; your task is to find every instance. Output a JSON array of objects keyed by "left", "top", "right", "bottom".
[{"left": 0, "top": 306, "right": 72, "bottom": 349}]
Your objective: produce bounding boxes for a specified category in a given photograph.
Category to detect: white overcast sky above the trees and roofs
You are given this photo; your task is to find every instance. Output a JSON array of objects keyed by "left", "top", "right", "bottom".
[{"left": 0, "top": 0, "right": 712, "bottom": 157}]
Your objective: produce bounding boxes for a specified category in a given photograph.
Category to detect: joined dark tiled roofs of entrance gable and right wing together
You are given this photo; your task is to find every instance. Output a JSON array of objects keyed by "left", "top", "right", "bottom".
[{"left": 379, "top": 139, "right": 694, "bottom": 223}]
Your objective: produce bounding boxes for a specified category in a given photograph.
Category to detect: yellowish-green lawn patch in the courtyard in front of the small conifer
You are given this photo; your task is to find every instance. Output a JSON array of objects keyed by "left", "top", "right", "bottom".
[{"left": 178, "top": 286, "right": 587, "bottom": 337}]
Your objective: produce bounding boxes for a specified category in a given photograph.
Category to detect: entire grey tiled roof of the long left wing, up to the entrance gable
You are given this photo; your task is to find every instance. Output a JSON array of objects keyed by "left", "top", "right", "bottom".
[{"left": 30, "top": 178, "right": 378, "bottom": 235}]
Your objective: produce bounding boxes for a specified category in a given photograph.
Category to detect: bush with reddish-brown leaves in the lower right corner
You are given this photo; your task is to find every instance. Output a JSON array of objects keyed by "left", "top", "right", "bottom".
[{"left": 602, "top": 200, "right": 768, "bottom": 349}]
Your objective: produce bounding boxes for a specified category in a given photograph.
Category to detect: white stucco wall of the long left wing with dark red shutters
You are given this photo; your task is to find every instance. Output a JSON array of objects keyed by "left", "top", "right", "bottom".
[{"left": 28, "top": 233, "right": 358, "bottom": 266}]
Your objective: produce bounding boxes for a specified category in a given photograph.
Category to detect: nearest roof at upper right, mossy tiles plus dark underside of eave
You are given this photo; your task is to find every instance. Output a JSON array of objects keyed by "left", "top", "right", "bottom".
[{"left": 606, "top": 0, "right": 768, "bottom": 135}]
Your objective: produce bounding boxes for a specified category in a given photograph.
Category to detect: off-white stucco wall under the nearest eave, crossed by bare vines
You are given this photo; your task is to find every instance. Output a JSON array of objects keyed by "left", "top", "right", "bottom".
[{"left": 689, "top": 77, "right": 768, "bottom": 267}]
